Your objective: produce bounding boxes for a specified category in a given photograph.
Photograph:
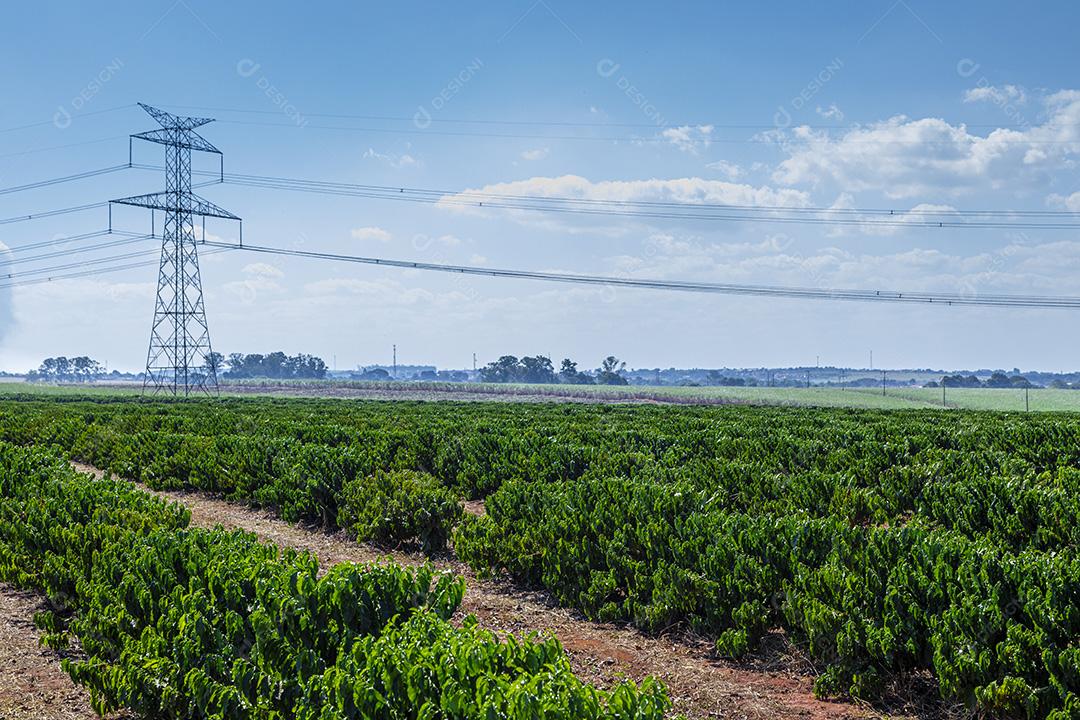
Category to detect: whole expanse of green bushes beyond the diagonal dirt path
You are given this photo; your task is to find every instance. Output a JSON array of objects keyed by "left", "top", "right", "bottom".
[{"left": 0, "top": 399, "right": 1080, "bottom": 718}]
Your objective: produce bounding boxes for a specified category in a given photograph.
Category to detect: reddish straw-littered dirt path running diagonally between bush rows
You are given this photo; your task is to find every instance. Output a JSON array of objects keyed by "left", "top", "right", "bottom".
[{"left": 59, "top": 464, "right": 873, "bottom": 720}]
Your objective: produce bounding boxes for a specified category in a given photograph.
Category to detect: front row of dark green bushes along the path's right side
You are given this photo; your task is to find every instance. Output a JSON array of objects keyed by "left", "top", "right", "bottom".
[{"left": 455, "top": 480, "right": 1080, "bottom": 718}]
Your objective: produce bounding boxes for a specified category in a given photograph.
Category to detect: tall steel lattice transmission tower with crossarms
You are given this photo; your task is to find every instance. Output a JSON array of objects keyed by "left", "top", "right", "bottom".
[{"left": 112, "top": 103, "right": 243, "bottom": 397}]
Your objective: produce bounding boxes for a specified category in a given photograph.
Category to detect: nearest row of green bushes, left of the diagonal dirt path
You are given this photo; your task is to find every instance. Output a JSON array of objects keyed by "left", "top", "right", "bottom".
[{"left": 0, "top": 443, "right": 669, "bottom": 720}]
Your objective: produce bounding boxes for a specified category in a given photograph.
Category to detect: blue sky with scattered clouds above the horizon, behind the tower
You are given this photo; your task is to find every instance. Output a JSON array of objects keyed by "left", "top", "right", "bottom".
[{"left": 0, "top": 0, "right": 1080, "bottom": 369}]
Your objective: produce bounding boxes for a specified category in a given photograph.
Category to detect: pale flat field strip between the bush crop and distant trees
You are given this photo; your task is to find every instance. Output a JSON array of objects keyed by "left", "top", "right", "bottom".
[{"left": 8, "top": 381, "right": 1080, "bottom": 412}]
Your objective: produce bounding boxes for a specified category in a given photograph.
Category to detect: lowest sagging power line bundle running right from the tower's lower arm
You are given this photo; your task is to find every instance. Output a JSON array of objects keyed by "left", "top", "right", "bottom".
[{"left": 200, "top": 243, "right": 1080, "bottom": 308}]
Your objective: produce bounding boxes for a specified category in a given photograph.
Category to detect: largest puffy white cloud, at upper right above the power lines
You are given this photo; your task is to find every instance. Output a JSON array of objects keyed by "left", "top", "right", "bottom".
[{"left": 765, "top": 91, "right": 1080, "bottom": 198}]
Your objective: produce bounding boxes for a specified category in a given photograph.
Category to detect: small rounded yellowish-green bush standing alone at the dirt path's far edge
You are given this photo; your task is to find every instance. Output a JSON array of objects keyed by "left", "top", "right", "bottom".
[{"left": 338, "top": 470, "right": 462, "bottom": 553}]
